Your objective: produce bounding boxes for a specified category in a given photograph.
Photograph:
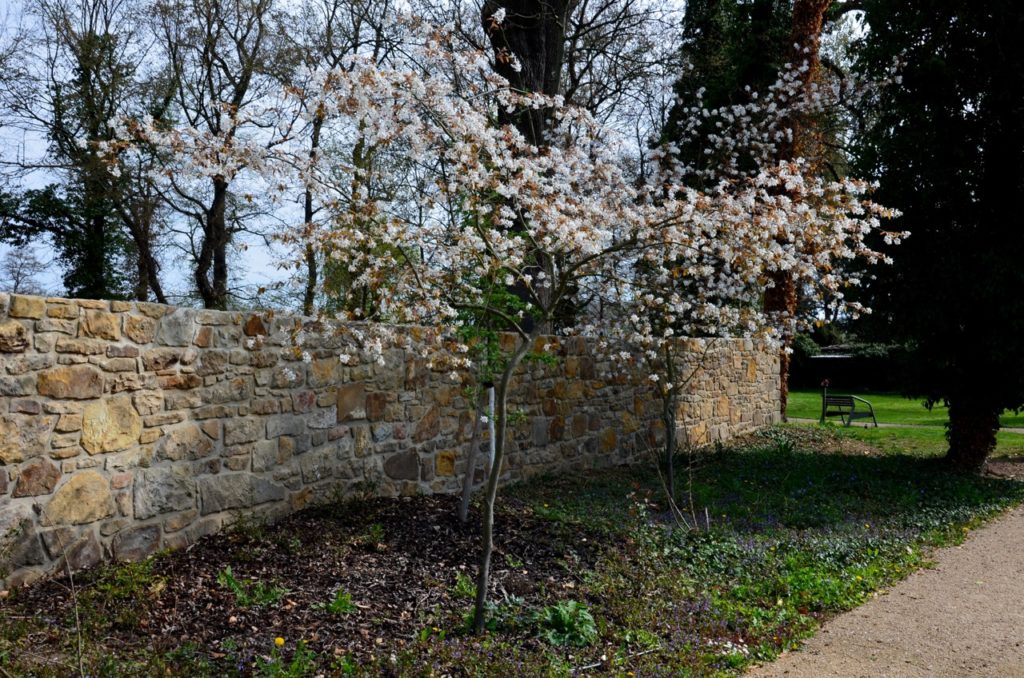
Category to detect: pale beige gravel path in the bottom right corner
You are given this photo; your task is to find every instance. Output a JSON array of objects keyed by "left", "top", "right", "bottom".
[{"left": 748, "top": 508, "right": 1024, "bottom": 678}]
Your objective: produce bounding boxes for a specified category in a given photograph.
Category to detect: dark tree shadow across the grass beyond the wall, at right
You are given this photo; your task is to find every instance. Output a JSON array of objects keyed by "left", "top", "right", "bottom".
[{"left": 693, "top": 444, "right": 1024, "bottom": 533}]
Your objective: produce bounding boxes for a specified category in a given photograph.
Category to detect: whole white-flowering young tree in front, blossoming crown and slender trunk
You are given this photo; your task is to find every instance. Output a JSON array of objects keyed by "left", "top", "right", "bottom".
[{"left": 119, "top": 16, "right": 901, "bottom": 631}]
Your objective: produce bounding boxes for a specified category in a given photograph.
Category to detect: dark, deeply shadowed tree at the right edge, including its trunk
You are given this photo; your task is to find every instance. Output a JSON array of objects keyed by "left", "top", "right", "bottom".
[{"left": 857, "top": 0, "right": 1024, "bottom": 470}]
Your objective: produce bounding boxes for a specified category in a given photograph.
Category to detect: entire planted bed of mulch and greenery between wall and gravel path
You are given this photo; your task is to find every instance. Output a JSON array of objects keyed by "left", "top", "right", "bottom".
[{"left": 0, "top": 426, "right": 1024, "bottom": 676}]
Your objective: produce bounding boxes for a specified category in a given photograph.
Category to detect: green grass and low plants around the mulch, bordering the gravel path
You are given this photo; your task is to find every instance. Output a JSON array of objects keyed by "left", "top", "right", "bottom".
[{"left": 0, "top": 426, "right": 1024, "bottom": 676}]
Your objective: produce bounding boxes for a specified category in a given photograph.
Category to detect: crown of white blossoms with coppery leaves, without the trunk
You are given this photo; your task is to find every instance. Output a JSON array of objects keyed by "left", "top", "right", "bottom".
[{"left": 114, "top": 11, "right": 904, "bottom": 401}]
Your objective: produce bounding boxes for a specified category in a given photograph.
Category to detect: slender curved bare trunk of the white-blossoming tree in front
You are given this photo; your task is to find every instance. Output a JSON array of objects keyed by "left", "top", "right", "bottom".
[{"left": 473, "top": 332, "right": 538, "bottom": 634}]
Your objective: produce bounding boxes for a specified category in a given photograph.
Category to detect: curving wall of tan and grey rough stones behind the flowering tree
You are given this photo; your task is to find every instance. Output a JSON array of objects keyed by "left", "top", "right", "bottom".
[{"left": 0, "top": 294, "right": 778, "bottom": 588}]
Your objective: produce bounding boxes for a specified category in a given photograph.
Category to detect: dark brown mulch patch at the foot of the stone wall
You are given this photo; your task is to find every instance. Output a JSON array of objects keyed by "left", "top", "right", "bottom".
[{"left": 6, "top": 496, "right": 598, "bottom": 663}]
